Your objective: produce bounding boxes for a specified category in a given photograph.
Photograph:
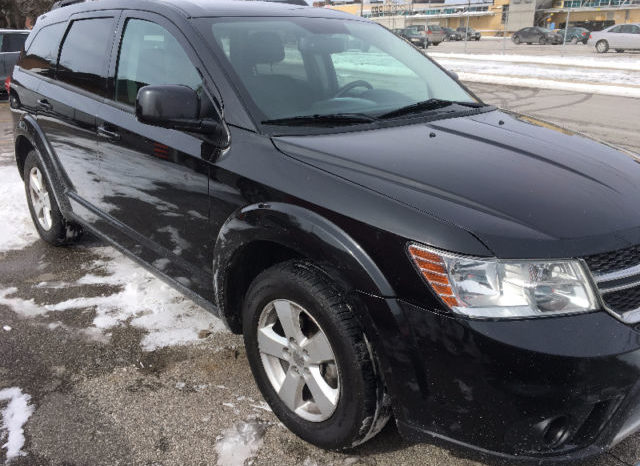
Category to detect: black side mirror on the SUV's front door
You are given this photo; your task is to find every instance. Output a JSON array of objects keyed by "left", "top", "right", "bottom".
[{"left": 136, "top": 85, "right": 228, "bottom": 147}]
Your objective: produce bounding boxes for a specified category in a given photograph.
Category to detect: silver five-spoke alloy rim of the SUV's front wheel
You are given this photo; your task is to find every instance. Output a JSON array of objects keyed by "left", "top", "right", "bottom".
[{"left": 258, "top": 299, "right": 340, "bottom": 422}]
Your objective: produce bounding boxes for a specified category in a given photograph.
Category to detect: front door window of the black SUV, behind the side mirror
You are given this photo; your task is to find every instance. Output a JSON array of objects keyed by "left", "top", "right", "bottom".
[{"left": 116, "top": 19, "right": 202, "bottom": 105}]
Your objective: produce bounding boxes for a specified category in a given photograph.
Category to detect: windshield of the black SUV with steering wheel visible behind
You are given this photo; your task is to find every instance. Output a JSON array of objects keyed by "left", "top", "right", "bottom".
[{"left": 195, "top": 17, "right": 477, "bottom": 124}]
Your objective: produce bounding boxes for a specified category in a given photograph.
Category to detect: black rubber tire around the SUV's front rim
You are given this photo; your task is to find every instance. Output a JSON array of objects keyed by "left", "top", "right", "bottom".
[{"left": 242, "top": 261, "right": 391, "bottom": 450}]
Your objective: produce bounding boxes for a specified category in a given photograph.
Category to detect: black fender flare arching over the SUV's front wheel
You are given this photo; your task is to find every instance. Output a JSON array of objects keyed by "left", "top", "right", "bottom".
[{"left": 213, "top": 202, "right": 395, "bottom": 332}]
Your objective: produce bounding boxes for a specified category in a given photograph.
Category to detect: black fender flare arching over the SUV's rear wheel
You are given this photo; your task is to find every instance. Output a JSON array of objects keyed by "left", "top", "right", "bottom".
[{"left": 14, "top": 113, "right": 71, "bottom": 215}]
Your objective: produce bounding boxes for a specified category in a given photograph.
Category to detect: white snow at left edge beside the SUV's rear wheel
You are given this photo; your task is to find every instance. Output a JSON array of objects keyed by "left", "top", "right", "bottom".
[{"left": 0, "top": 153, "right": 38, "bottom": 252}]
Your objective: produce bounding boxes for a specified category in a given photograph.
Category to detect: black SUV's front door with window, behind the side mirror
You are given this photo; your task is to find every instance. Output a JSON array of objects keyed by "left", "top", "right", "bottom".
[{"left": 97, "top": 12, "right": 213, "bottom": 296}]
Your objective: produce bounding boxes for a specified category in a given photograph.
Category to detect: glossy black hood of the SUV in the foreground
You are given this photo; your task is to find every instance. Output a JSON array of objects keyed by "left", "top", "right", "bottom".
[{"left": 274, "top": 111, "right": 640, "bottom": 258}]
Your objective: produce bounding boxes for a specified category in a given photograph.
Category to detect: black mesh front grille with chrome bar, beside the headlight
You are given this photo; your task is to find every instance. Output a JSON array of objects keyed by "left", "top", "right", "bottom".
[{"left": 584, "top": 246, "right": 640, "bottom": 323}]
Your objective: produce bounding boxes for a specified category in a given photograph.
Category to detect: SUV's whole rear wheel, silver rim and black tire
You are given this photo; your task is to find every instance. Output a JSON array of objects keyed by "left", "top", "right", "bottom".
[{"left": 23, "top": 151, "right": 82, "bottom": 246}]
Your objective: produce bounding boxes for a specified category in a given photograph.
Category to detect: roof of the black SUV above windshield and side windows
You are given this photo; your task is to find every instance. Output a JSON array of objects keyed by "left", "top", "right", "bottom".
[{"left": 44, "top": 0, "right": 364, "bottom": 21}]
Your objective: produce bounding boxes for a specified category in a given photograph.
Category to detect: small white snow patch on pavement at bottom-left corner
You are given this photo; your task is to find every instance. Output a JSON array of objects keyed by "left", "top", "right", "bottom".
[{"left": 0, "top": 387, "right": 33, "bottom": 462}]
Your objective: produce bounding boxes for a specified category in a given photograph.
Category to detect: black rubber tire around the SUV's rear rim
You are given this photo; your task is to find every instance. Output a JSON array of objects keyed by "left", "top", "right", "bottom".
[{"left": 23, "top": 151, "right": 82, "bottom": 246}]
